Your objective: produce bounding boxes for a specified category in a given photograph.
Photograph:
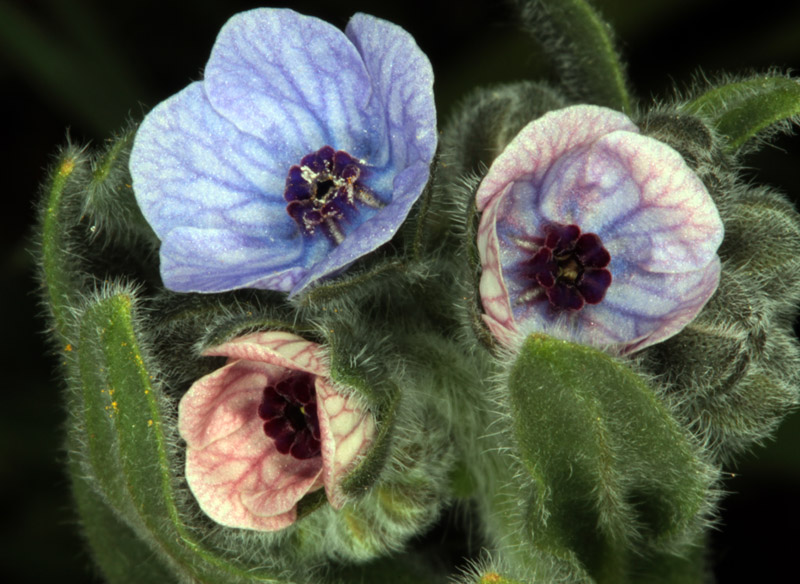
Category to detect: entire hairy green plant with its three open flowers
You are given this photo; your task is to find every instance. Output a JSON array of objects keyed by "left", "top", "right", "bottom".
[{"left": 38, "top": 0, "right": 800, "bottom": 584}]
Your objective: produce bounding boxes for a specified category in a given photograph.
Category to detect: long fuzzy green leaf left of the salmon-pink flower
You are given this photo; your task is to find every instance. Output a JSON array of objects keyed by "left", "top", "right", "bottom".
[{"left": 70, "top": 288, "right": 296, "bottom": 584}]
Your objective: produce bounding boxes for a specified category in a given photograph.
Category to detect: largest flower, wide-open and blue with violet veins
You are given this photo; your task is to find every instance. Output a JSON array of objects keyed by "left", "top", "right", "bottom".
[{"left": 130, "top": 9, "right": 437, "bottom": 294}]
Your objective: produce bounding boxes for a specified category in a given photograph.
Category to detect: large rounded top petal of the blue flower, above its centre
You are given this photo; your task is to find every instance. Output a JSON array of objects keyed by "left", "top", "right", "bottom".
[{"left": 205, "top": 8, "right": 384, "bottom": 163}]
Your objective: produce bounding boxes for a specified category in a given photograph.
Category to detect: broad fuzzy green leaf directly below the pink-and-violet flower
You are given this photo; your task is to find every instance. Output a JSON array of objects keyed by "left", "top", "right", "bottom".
[{"left": 508, "top": 335, "right": 715, "bottom": 582}]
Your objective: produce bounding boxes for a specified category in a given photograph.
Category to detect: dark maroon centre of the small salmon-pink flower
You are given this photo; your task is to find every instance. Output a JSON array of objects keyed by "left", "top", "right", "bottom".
[{"left": 258, "top": 372, "right": 320, "bottom": 460}]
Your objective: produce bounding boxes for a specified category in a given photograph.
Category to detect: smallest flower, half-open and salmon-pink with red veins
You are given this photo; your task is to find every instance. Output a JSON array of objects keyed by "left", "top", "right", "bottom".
[{"left": 178, "top": 331, "right": 375, "bottom": 531}]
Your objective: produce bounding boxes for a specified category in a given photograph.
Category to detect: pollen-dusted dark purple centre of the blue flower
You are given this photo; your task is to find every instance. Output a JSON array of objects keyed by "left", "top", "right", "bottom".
[{"left": 283, "top": 146, "right": 382, "bottom": 244}]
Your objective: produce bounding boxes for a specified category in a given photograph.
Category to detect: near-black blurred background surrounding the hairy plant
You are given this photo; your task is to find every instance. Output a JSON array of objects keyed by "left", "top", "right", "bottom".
[{"left": 0, "top": 0, "right": 800, "bottom": 583}]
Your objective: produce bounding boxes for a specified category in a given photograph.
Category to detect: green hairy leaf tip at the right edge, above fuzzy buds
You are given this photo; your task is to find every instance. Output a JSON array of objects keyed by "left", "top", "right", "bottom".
[{"left": 683, "top": 75, "right": 800, "bottom": 152}]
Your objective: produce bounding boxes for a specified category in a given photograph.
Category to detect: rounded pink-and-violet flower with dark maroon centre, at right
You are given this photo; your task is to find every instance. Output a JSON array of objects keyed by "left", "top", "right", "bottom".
[{"left": 476, "top": 105, "right": 723, "bottom": 352}]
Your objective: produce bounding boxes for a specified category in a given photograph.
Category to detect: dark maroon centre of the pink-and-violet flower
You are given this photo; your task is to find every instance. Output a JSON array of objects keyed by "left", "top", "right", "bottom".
[{"left": 520, "top": 223, "right": 611, "bottom": 311}]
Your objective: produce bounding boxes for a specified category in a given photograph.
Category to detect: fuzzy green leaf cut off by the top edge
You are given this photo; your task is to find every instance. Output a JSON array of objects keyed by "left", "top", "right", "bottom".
[{"left": 518, "top": 0, "right": 631, "bottom": 114}]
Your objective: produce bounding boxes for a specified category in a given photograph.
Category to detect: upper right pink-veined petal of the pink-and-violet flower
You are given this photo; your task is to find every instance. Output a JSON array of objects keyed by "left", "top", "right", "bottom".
[{"left": 540, "top": 131, "right": 723, "bottom": 272}]
